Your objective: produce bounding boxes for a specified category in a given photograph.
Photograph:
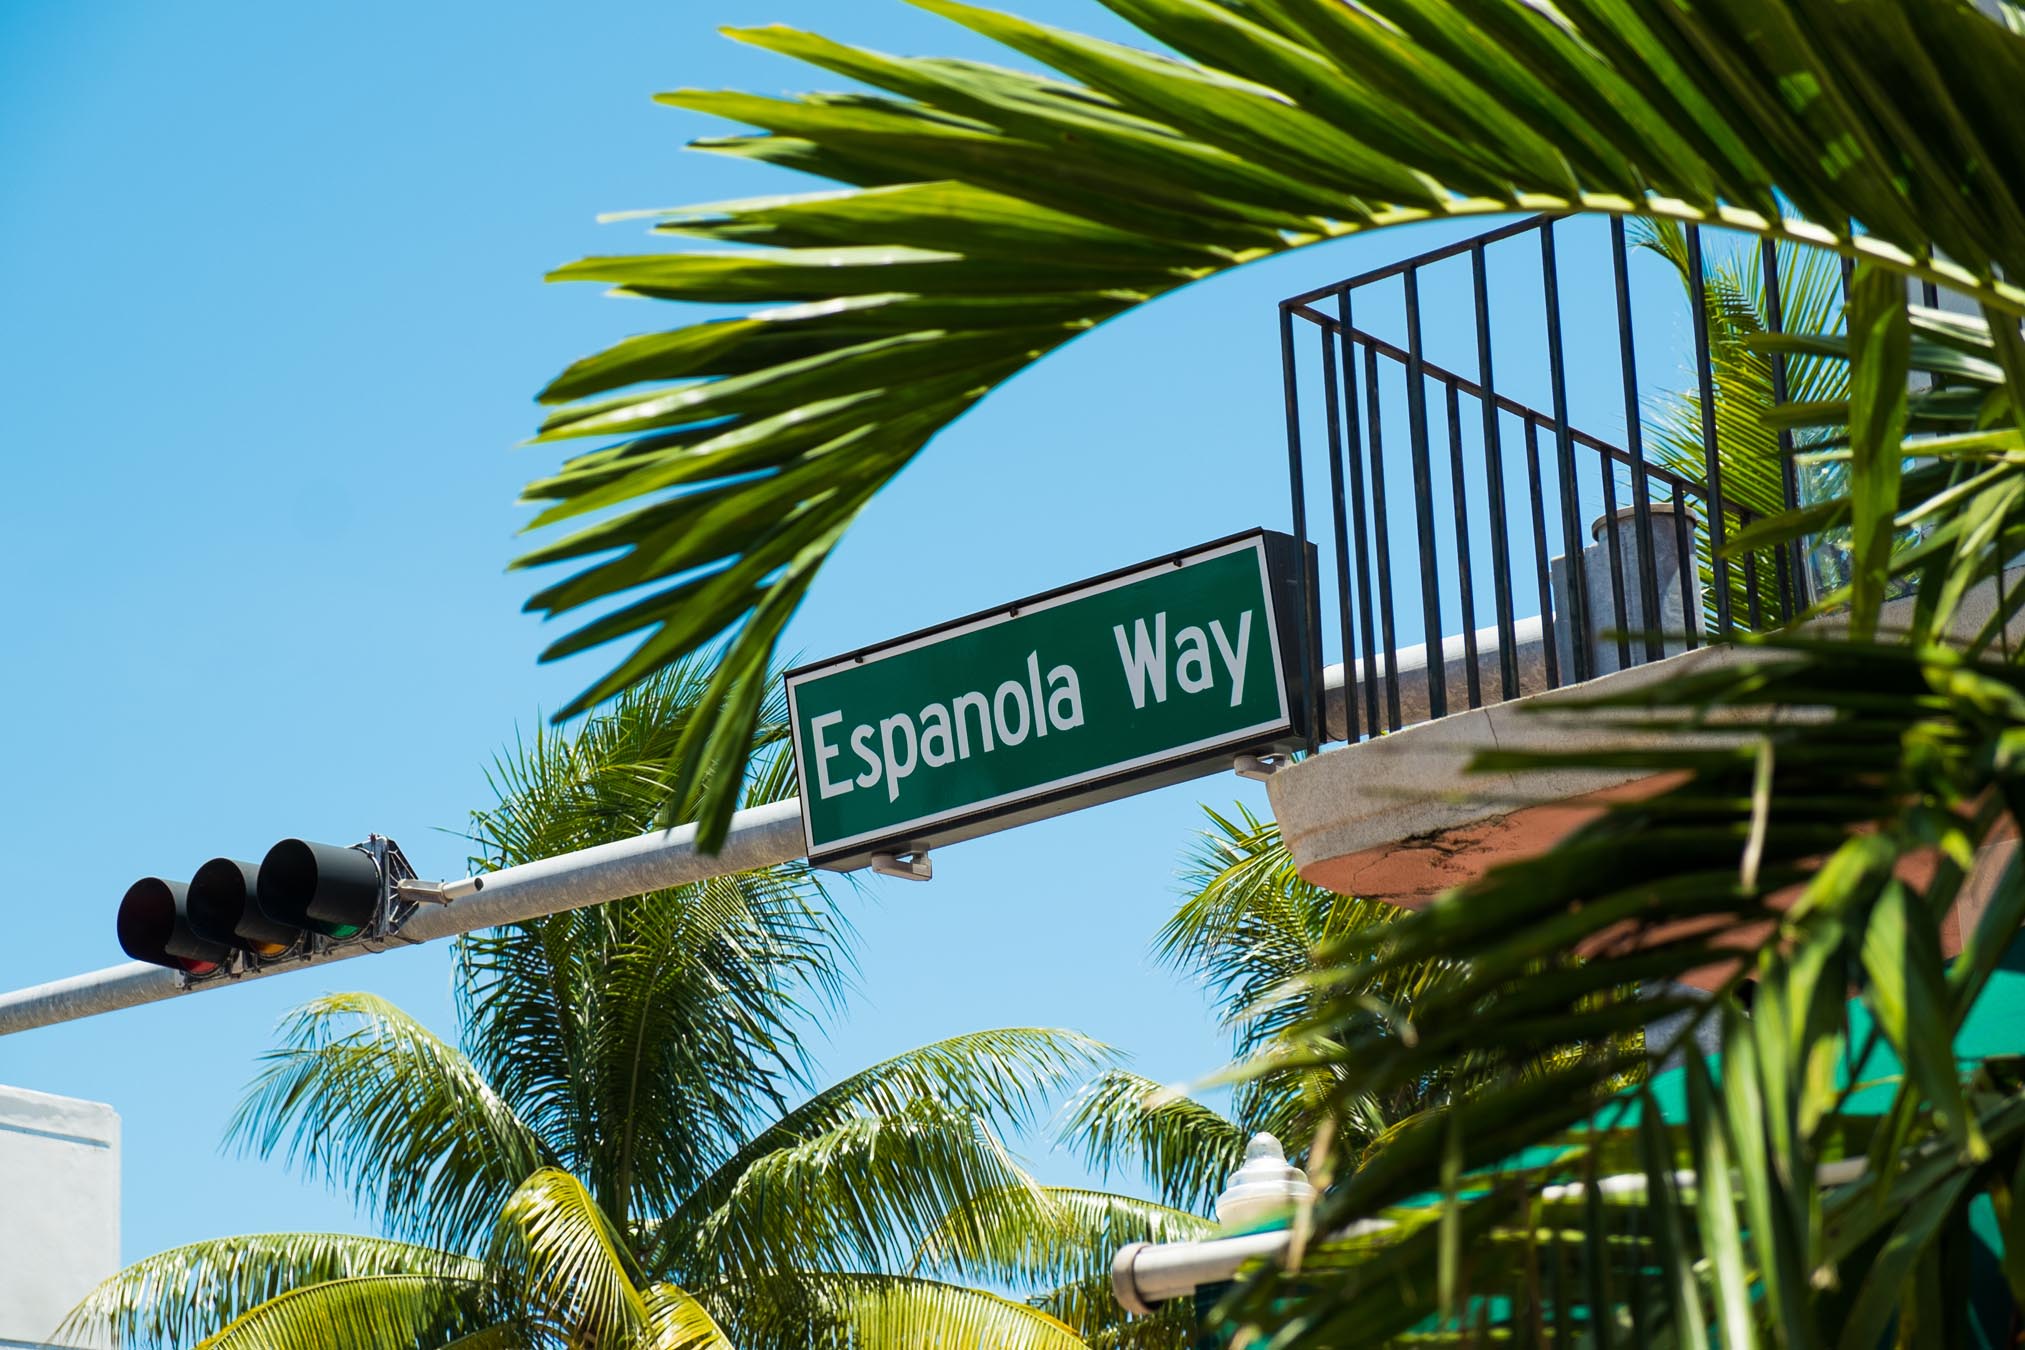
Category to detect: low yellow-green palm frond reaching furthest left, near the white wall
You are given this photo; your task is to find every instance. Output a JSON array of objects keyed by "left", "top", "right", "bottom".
[{"left": 57, "top": 1233, "right": 482, "bottom": 1346}]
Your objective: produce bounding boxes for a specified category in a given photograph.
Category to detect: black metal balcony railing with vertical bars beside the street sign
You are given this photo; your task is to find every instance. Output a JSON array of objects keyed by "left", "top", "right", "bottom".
[{"left": 1280, "top": 217, "right": 1810, "bottom": 741}]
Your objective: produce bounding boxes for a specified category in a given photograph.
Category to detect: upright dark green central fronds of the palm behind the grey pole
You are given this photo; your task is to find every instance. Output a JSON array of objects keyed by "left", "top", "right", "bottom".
[{"left": 458, "top": 662, "right": 851, "bottom": 1225}]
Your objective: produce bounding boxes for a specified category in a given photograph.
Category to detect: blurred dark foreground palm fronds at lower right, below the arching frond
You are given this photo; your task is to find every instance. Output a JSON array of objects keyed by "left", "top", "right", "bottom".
[{"left": 1198, "top": 267, "right": 2025, "bottom": 1346}]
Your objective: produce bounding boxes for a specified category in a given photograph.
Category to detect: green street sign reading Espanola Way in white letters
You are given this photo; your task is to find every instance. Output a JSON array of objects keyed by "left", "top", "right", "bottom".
[{"left": 788, "top": 530, "right": 1320, "bottom": 868}]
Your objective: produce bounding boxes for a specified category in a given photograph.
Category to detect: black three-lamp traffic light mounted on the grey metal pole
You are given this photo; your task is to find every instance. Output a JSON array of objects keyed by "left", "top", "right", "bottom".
[{"left": 117, "top": 834, "right": 415, "bottom": 976}]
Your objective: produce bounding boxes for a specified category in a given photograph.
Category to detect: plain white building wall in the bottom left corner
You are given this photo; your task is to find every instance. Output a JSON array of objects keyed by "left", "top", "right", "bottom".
[{"left": 0, "top": 1087, "right": 119, "bottom": 1350}]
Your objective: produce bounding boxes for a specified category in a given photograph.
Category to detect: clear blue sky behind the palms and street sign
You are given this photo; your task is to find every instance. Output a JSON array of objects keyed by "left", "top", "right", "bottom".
[{"left": 0, "top": 0, "right": 1709, "bottom": 1257}]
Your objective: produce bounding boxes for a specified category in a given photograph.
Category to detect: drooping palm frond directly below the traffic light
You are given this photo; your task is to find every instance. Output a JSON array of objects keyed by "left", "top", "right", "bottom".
[{"left": 229, "top": 994, "right": 549, "bottom": 1249}]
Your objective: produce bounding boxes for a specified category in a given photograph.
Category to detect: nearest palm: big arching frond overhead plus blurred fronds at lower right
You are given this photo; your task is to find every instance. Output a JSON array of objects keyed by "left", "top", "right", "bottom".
[{"left": 494, "top": 0, "right": 2025, "bottom": 1346}]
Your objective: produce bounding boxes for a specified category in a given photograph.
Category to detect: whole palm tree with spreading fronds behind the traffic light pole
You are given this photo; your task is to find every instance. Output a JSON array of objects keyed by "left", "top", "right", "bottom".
[{"left": 69, "top": 662, "right": 1110, "bottom": 1350}]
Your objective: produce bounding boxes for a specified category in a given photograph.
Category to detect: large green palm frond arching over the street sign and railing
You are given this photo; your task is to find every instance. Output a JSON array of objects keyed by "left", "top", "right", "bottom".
[{"left": 520, "top": 0, "right": 2025, "bottom": 846}]
